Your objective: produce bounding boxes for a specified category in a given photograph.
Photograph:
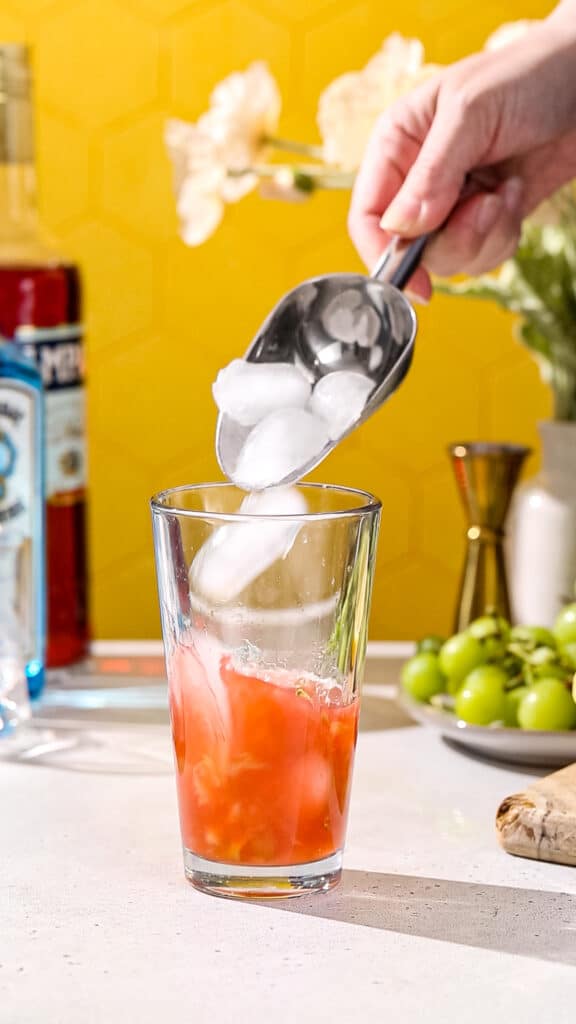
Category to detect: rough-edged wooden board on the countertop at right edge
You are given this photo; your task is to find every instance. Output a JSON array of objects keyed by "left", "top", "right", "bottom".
[{"left": 496, "top": 764, "right": 576, "bottom": 866}]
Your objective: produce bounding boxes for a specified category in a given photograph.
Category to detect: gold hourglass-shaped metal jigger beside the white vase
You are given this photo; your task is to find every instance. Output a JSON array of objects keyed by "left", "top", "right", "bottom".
[{"left": 448, "top": 442, "right": 530, "bottom": 631}]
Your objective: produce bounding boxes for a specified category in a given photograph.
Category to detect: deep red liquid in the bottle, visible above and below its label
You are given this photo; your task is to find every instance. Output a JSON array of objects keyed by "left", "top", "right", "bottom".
[{"left": 0, "top": 263, "right": 88, "bottom": 666}]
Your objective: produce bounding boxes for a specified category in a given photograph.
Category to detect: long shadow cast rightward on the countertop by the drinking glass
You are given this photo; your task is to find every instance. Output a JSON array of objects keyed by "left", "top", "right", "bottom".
[{"left": 262, "top": 870, "right": 576, "bottom": 966}]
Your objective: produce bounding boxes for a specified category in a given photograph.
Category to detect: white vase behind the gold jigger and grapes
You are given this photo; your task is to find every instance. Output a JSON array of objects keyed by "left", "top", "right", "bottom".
[{"left": 507, "top": 421, "right": 576, "bottom": 626}]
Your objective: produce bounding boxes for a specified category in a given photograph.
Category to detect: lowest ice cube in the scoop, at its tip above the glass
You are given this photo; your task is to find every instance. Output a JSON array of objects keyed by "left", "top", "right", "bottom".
[{"left": 232, "top": 408, "right": 329, "bottom": 490}]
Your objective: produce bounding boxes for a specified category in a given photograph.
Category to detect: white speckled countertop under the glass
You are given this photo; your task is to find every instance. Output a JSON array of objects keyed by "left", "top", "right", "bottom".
[{"left": 0, "top": 659, "right": 576, "bottom": 1024}]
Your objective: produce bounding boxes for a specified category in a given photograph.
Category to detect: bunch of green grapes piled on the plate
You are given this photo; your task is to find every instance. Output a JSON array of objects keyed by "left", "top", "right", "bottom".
[{"left": 402, "top": 603, "right": 576, "bottom": 730}]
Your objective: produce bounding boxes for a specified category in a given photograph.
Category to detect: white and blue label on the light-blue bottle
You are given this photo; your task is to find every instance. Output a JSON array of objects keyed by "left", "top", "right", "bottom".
[{"left": 0, "top": 378, "right": 42, "bottom": 658}]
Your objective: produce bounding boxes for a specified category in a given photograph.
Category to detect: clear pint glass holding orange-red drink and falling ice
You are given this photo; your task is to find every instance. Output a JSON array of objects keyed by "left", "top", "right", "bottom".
[{"left": 152, "top": 484, "right": 380, "bottom": 898}]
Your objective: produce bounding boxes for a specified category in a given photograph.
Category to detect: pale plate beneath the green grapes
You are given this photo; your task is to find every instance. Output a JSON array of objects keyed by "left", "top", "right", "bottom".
[{"left": 399, "top": 691, "right": 576, "bottom": 768}]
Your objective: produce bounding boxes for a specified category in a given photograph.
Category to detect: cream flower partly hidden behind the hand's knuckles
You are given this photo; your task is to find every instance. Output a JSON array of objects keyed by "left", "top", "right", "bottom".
[{"left": 318, "top": 33, "right": 437, "bottom": 170}]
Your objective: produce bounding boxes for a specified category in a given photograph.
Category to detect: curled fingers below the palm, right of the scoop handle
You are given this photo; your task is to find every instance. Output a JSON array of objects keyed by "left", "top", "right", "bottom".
[{"left": 423, "top": 177, "right": 524, "bottom": 278}]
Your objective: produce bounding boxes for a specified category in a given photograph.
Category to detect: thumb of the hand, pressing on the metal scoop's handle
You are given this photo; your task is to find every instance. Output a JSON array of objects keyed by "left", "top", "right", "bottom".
[{"left": 380, "top": 111, "right": 480, "bottom": 238}]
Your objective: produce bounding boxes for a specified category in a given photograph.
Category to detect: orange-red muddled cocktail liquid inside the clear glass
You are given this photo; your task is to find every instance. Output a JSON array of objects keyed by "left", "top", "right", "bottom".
[{"left": 169, "top": 644, "right": 359, "bottom": 866}]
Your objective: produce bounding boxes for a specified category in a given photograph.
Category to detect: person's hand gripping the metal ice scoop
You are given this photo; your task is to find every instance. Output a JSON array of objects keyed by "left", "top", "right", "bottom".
[{"left": 348, "top": 9, "right": 576, "bottom": 299}]
